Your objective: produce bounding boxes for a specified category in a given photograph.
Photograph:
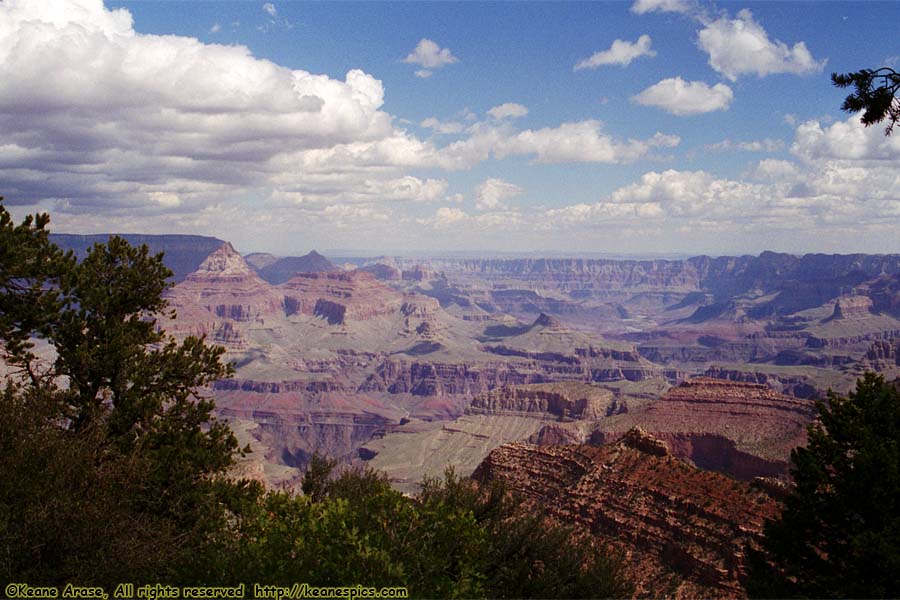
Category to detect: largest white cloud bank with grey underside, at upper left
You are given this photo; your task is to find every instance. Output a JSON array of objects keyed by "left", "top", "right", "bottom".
[{"left": 0, "top": 0, "right": 468, "bottom": 223}]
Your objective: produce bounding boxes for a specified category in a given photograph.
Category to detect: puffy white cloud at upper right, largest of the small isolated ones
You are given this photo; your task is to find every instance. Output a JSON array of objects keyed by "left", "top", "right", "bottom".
[{"left": 697, "top": 9, "right": 826, "bottom": 81}]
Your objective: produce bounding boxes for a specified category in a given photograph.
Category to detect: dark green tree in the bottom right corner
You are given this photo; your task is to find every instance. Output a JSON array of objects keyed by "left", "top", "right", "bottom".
[{"left": 748, "top": 373, "right": 900, "bottom": 598}]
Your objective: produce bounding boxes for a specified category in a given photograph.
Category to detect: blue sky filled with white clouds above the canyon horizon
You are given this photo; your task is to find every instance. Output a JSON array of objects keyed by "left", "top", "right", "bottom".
[{"left": 0, "top": 0, "right": 900, "bottom": 256}]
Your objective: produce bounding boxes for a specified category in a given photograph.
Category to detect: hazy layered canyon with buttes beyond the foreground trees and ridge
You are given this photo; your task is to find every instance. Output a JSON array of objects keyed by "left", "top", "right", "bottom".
[{"left": 44, "top": 235, "right": 900, "bottom": 493}]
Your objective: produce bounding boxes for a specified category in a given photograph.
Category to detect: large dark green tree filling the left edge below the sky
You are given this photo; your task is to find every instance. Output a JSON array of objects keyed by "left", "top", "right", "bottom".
[{"left": 0, "top": 199, "right": 260, "bottom": 583}]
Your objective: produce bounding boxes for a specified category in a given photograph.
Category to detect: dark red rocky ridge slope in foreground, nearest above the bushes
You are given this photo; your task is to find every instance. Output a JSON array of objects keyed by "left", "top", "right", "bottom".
[{"left": 473, "top": 431, "right": 779, "bottom": 597}]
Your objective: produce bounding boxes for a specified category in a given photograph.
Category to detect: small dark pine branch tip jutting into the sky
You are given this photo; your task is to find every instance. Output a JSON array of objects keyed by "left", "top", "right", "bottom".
[{"left": 831, "top": 67, "right": 900, "bottom": 135}]
